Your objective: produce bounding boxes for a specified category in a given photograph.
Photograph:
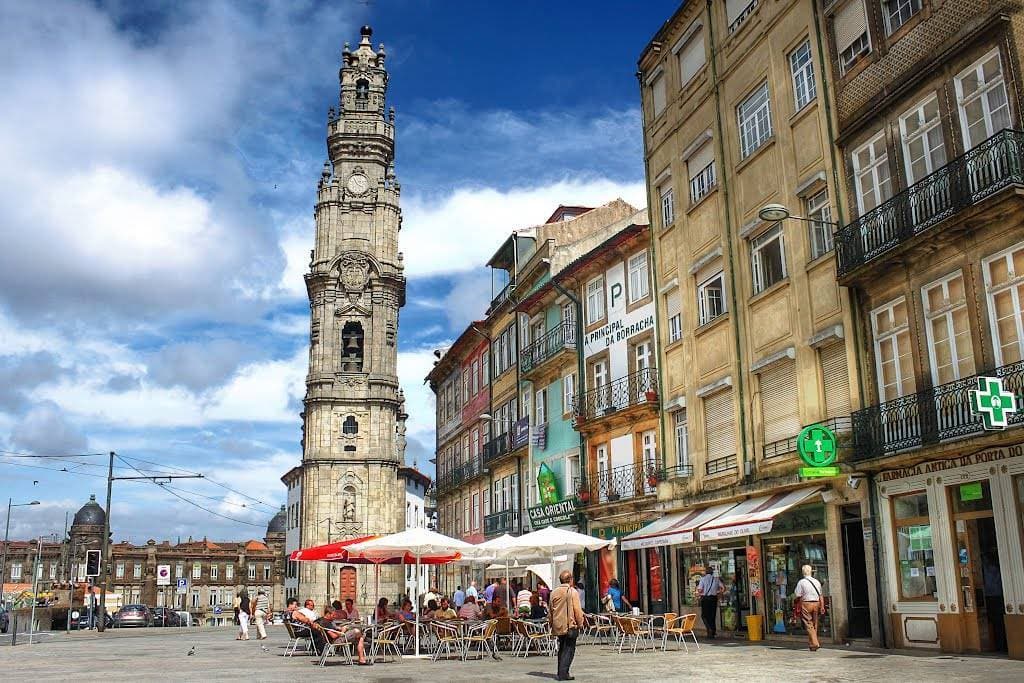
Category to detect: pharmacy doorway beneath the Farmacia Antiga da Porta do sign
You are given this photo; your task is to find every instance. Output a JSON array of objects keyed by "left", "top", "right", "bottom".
[{"left": 947, "top": 480, "right": 1007, "bottom": 652}]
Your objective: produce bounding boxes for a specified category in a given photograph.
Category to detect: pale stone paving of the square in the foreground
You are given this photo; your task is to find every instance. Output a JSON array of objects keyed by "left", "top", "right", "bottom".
[{"left": 0, "top": 627, "right": 1024, "bottom": 683}]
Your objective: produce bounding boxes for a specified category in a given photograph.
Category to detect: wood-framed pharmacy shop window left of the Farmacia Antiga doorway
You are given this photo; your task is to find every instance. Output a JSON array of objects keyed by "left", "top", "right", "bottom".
[{"left": 892, "top": 492, "right": 937, "bottom": 600}]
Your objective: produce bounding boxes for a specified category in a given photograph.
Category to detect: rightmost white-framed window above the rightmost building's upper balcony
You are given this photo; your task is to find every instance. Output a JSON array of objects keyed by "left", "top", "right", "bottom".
[{"left": 956, "top": 50, "right": 1010, "bottom": 150}]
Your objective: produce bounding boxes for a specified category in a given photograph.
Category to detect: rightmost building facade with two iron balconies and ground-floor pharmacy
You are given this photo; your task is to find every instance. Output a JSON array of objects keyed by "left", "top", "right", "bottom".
[{"left": 824, "top": 0, "right": 1024, "bottom": 658}]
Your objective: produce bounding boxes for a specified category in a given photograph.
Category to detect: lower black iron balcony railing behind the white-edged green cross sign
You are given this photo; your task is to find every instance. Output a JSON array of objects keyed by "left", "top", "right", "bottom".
[{"left": 850, "top": 360, "right": 1024, "bottom": 461}]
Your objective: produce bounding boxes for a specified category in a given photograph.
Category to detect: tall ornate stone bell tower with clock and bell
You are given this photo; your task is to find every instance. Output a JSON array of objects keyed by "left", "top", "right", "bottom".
[{"left": 299, "top": 27, "right": 406, "bottom": 608}]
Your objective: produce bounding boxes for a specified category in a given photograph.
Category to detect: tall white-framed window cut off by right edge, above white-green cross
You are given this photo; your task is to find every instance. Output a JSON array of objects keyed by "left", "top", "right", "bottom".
[{"left": 984, "top": 243, "right": 1024, "bottom": 366}]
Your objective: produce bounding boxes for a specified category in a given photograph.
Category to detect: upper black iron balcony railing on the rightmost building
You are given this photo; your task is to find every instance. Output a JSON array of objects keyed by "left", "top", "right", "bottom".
[{"left": 836, "top": 129, "right": 1024, "bottom": 278}]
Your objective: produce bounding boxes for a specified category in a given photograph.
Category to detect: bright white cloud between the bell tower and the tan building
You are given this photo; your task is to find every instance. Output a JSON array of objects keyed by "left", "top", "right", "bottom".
[{"left": 399, "top": 179, "right": 647, "bottom": 278}]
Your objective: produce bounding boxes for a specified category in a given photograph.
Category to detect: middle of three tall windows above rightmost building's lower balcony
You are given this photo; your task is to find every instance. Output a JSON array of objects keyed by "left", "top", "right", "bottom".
[{"left": 921, "top": 270, "right": 974, "bottom": 385}]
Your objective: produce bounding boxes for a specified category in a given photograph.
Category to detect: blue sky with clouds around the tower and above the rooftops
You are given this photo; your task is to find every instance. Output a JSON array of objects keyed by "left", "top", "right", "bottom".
[{"left": 0, "top": 0, "right": 677, "bottom": 541}]
